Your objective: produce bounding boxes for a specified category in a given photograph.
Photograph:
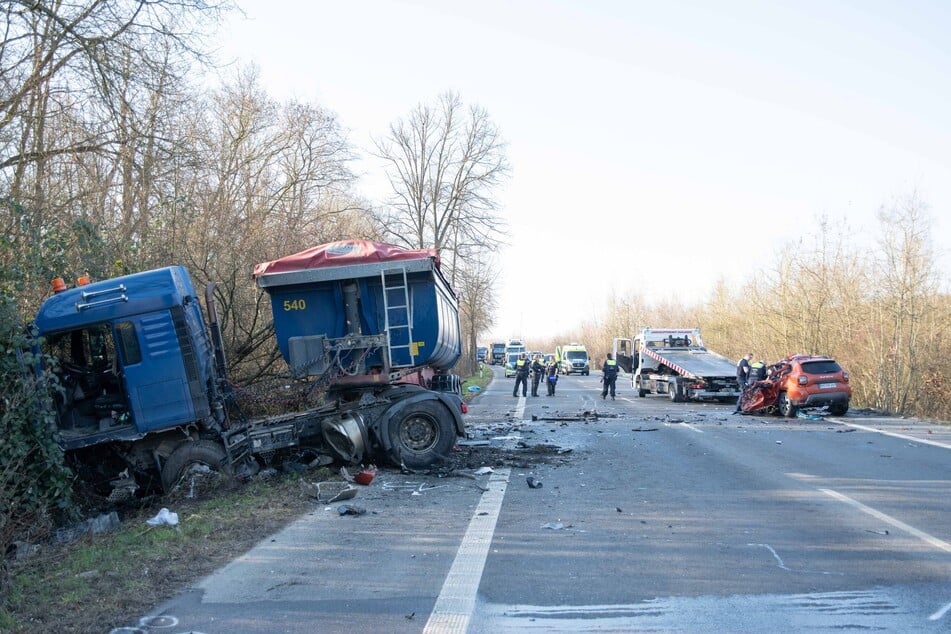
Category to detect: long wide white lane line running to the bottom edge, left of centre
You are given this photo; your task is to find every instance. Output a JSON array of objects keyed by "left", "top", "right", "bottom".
[{"left": 423, "top": 469, "right": 509, "bottom": 634}]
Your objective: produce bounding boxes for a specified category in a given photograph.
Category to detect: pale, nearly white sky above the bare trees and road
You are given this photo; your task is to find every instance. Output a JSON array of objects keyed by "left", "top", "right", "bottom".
[{"left": 222, "top": 0, "right": 951, "bottom": 340}]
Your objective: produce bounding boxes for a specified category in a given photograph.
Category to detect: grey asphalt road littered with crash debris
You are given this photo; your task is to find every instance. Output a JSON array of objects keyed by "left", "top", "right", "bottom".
[{"left": 117, "top": 368, "right": 951, "bottom": 633}]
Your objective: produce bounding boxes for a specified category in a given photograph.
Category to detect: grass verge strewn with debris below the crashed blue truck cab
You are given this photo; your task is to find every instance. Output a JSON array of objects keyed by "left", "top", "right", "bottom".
[{"left": 0, "top": 469, "right": 320, "bottom": 634}]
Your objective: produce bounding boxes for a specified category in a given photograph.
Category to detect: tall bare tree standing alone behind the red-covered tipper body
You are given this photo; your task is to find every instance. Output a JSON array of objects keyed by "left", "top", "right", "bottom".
[{"left": 376, "top": 93, "right": 509, "bottom": 284}]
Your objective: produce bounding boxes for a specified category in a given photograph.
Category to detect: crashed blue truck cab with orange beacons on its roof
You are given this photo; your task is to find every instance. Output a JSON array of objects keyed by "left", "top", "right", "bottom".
[{"left": 34, "top": 266, "right": 221, "bottom": 450}]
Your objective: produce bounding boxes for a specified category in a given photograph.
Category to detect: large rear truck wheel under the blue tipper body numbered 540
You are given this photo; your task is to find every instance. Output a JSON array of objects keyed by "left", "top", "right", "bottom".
[{"left": 388, "top": 401, "right": 456, "bottom": 469}]
